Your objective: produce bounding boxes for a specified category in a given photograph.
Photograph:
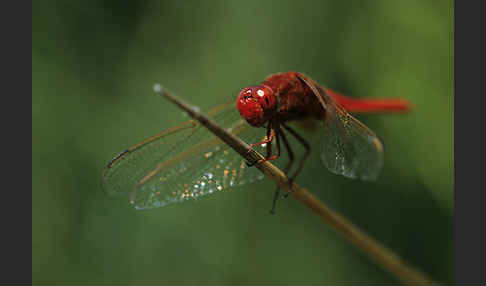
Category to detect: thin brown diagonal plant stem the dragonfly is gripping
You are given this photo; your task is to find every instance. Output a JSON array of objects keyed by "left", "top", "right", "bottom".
[{"left": 154, "top": 84, "right": 439, "bottom": 285}]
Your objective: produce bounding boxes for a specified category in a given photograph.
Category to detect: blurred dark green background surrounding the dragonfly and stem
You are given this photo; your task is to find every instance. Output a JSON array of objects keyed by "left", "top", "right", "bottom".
[{"left": 32, "top": 0, "right": 454, "bottom": 285}]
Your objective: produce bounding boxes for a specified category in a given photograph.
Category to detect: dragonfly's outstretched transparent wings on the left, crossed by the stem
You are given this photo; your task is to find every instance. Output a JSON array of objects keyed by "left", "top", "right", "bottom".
[{"left": 102, "top": 100, "right": 272, "bottom": 209}]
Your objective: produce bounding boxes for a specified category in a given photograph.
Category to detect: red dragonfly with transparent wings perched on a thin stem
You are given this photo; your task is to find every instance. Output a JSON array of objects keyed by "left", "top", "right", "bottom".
[{"left": 102, "top": 72, "right": 410, "bottom": 211}]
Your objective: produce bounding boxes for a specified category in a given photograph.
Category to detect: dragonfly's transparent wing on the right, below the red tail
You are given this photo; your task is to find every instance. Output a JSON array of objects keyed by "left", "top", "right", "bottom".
[{"left": 317, "top": 86, "right": 384, "bottom": 181}]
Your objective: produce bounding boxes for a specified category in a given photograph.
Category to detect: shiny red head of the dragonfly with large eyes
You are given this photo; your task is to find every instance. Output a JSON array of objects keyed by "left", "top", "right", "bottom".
[{"left": 237, "top": 85, "right": 277, "bottom": 127}]
